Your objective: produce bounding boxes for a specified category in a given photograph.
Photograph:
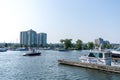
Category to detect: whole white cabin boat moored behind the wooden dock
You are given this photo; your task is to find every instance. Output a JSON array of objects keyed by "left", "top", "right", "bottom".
[{"left": 79, "top": 51, "right": 120, "bottom": 66}]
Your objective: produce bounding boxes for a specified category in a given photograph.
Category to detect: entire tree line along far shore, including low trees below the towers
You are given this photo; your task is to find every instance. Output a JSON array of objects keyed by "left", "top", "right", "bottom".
[{"left": 3, "top": 39, "right": 112, "bottom": 50}]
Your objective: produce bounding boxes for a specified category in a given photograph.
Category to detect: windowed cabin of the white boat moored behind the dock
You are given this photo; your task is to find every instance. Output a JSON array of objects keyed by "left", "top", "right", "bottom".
[{"left": 88, "top": 51, "right": 112, "bottom": 65}]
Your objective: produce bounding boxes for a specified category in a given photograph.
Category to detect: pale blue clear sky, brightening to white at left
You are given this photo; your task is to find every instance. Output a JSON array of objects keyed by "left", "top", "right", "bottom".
[{"left": 0, "top": 0, "right": 120, "bottom": 43}]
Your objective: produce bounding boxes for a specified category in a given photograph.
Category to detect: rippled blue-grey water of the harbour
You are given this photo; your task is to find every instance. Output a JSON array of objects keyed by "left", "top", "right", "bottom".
[{"left": 0, "top": 50, "right": 120, "bottom": 80}]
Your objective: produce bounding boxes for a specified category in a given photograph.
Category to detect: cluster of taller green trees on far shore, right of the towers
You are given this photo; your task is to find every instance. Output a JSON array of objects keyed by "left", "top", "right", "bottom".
[{"left": 60, "top": 39, "right": 112, "bottom": 50}]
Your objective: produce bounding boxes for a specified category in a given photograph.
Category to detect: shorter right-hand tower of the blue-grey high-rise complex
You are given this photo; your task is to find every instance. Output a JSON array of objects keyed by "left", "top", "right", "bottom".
[{"left": 37, "top": 33, "right": 47, "bottom": 47}]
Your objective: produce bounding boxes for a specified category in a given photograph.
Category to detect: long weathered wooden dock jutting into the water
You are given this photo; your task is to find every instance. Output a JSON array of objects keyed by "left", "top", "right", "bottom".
[{"left": 58, "top": 60, "right": 120, "bottom": 73}]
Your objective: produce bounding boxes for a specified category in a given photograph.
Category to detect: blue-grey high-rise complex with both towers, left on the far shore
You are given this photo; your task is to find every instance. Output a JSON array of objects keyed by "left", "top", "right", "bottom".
[{"left": 20, "top": 29, "right": 47, "bottom": 47}]
